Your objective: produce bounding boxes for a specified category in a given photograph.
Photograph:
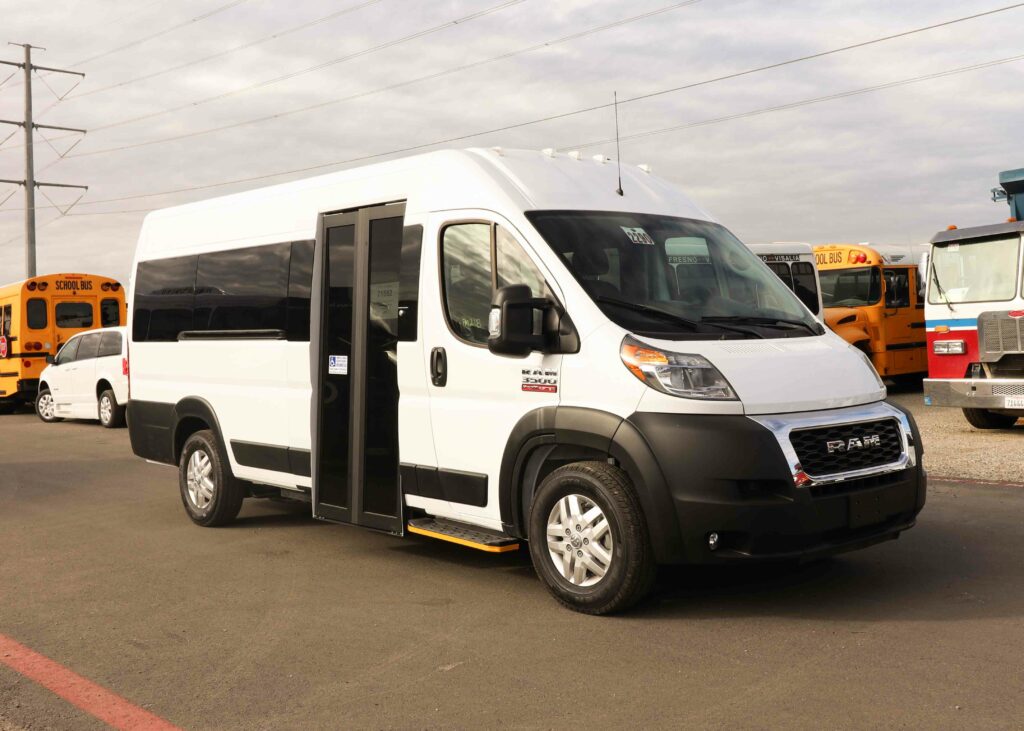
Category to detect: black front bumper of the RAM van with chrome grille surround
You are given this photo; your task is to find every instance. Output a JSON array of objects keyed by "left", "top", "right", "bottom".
[{"left": 628, "top": 402, "right": 927, "bottom": 563}]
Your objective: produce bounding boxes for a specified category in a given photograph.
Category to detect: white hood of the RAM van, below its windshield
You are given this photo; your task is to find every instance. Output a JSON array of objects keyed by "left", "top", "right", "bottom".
[{"left": 641, "top": 332, "right": 886, "bottom": 415}]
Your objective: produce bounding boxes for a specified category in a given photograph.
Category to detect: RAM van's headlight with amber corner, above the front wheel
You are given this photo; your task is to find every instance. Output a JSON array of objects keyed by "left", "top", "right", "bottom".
[{"left": 620, "top": 336, "right": 736, "bottom": 401}]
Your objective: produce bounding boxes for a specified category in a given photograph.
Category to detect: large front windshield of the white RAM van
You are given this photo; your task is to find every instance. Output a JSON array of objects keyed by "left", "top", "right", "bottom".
[{"left": 526, "top": 211, "right": 822, "bottom": 340}]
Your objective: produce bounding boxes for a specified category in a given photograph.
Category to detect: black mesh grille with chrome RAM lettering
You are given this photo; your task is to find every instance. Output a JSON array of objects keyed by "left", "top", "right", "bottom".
[{"left": 790, "top": 419, "right": 903, "bottom": 477}]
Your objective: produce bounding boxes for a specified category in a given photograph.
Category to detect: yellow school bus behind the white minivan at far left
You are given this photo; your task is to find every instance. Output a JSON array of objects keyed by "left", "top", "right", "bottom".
[{"left": 0, "top": 273, "right": 127, "bottom": 412}]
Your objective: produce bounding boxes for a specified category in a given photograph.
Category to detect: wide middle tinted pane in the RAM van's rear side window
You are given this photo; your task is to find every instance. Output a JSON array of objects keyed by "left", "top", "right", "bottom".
[{"left": 191, "top": 244, "right": 291, "bottom": 331}]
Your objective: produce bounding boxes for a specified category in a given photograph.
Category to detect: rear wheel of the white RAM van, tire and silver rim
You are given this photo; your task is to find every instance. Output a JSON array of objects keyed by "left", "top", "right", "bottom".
[{"left": 178, "top": 429, "right": 245, "bottom": 527}]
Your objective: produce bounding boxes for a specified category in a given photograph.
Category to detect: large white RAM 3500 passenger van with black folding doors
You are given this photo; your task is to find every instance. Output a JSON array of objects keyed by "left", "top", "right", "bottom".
[{"left": 128, "top": 149, "right": 925, "bottom": 613}]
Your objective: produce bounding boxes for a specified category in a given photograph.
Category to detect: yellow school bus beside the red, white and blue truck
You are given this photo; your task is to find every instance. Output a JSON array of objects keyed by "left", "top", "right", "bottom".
[{"left": 814, "top": 244, "right": 928, "bottom": 378}]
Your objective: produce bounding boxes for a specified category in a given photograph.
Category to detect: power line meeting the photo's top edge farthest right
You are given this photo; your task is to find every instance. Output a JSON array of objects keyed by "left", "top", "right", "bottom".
[{"left": 71, "top": 0, "right": 701, "bottom": 158}]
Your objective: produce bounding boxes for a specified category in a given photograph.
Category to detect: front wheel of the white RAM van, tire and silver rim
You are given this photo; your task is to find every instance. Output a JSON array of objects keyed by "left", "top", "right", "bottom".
[{"left": 529, "top": 462, "right": 655, "bottom": 614}]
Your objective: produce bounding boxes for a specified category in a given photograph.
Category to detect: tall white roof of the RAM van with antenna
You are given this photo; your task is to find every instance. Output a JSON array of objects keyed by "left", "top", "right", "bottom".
[{"left": 137, "top": 148, "right": 714, "bottom": 260}]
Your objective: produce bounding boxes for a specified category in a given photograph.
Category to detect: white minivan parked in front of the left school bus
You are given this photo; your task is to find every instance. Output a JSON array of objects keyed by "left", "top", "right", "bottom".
[{"left": 36, "top": 328, "right": 128, "bottom": 429}]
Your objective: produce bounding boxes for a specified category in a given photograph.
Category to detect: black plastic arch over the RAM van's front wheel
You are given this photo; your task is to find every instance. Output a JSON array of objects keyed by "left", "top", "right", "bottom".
[{"left": 499, "top": 406, "right": 681, "bottom": 561}]
